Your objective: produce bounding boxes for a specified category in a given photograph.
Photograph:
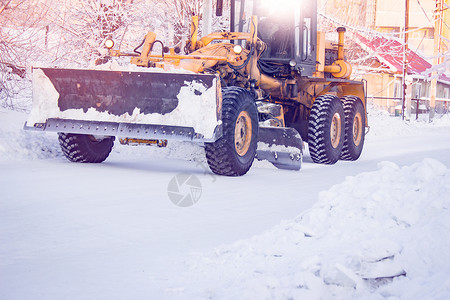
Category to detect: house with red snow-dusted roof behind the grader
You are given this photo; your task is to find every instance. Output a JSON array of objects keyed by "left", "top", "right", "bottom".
[{"left": 352, "top": 33, "right": 450, "bottom": 114}]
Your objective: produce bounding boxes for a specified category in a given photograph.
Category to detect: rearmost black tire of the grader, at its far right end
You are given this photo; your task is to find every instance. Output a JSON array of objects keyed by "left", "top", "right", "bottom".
[{"left": 340, "top": 96, "right": 366, "bottom": 160}]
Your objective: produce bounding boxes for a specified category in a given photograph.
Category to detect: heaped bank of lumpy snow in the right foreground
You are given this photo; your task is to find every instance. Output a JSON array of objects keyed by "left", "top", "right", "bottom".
[{"left": 177, "top": 159, "right": 450, "bottom": 299}]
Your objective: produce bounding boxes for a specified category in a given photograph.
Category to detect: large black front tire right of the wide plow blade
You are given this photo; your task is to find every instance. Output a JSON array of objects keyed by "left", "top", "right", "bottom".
[{"left": 205, "top": 87, "right": 259, "bottom": 176}]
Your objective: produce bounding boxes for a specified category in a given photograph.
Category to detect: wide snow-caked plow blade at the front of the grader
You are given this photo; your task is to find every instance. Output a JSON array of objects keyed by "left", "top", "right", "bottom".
[{"left": 25, "top": 68, "right": 221, "bottom": 142}]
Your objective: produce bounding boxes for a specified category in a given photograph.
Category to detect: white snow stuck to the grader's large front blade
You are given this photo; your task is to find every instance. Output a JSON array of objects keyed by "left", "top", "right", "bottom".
[{"left": 28, "top": 69, "right": 220, "bottom": 139}]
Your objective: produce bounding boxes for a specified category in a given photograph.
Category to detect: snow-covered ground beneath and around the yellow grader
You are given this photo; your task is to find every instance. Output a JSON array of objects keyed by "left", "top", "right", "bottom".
[{"left": 0, "top": 109, "right": 450, "bottom": 299}]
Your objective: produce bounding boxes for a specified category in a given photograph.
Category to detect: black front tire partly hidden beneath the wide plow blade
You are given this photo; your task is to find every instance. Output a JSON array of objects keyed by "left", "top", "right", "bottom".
[{"left": 58, "top": 132, "right": 115, "bottom": 163}]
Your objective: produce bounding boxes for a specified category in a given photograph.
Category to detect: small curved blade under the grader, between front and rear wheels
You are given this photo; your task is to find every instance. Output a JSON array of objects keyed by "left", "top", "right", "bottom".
[{"left": 256, "top": 127, "right": 303, "bottom": 170}]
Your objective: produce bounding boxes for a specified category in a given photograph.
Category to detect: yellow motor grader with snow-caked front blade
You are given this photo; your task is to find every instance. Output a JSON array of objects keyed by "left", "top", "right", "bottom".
[{"left": 25, "top": 0, "right": 367, "bottom": 176}]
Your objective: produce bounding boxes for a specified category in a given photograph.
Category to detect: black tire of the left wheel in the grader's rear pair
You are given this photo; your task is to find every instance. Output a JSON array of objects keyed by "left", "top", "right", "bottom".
[{"left": 308, "top": 95, "right": 345, "bottom": 164}]
